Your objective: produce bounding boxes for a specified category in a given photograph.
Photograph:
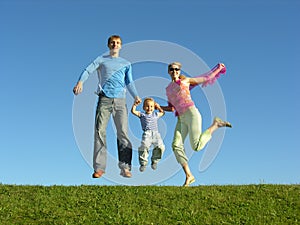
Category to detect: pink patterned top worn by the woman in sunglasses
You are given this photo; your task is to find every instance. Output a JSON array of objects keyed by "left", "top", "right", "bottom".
[{"left": 166, "top": 80, "right": 195, "bottom": 116}]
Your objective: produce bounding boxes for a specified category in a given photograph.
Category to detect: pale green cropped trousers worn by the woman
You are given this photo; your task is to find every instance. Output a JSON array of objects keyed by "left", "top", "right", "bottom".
[{"left": 172, "top": 106, "right": 211, "bottom": 165}]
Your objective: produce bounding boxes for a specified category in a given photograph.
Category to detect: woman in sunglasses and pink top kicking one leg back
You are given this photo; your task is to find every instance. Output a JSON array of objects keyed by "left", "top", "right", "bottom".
[{"left": 161, "top": 62, "right": 232, "bottom": 186}]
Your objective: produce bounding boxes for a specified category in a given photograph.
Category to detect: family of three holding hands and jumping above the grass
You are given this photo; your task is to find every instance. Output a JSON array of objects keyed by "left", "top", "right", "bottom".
[{"left": 73, "top": 35, "right": 231, "bottom": 186}]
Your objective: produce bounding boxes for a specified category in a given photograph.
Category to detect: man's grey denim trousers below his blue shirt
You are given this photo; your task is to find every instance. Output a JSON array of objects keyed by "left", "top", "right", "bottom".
[{"left": 93, "top": 94, "right": 132, "bottom": 172}]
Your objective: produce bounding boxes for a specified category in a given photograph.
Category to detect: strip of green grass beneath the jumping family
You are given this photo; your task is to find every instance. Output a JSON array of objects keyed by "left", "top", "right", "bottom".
[{"left": 0, "top": 184, "right": 300, "bottom": 225}]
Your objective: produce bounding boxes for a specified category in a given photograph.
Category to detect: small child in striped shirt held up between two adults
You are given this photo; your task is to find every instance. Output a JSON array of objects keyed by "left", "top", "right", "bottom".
[{"left": 131, "top": 98, "right": 165, "bottom": 172}]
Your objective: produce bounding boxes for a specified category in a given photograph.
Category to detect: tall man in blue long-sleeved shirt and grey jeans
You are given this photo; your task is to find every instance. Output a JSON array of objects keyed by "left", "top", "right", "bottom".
[{"left": 73, "top": 35, "right": 141, "bottom": 178}]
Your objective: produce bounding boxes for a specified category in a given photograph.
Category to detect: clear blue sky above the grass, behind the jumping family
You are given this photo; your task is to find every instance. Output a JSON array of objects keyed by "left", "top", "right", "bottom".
[{"left": 0, "top": 0, "right": 300, "bottom": 185}]
